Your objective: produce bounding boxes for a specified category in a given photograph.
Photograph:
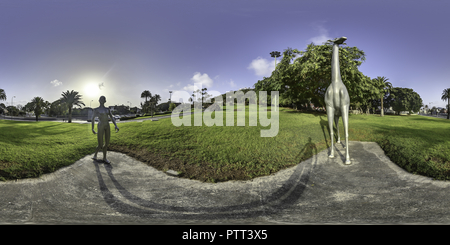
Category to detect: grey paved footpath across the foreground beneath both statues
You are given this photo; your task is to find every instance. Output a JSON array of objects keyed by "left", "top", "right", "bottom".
[{"left": 0, "top": 141, "right": 450, "bottom": 224}]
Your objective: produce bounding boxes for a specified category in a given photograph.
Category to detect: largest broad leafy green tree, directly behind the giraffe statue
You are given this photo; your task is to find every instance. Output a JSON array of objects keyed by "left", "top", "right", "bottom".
[{"left": 255, "top": 43, "right": 379, "bottom": 110}]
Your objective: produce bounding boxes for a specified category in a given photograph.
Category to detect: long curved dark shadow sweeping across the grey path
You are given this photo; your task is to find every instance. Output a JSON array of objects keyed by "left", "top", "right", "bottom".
[{"left": 89, "top": 143, "right": 317, "bottom": 220}]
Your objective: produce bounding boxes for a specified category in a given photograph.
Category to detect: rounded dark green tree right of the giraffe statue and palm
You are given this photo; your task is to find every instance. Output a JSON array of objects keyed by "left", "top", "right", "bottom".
[{"left": 386, "top": 87, "right": 423, "bottom": 114}]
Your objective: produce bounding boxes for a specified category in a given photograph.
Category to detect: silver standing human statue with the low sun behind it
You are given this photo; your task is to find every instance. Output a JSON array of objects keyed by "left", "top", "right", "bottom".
[{"left": 91, "top": 96, "right": 119, "bottom": 164}]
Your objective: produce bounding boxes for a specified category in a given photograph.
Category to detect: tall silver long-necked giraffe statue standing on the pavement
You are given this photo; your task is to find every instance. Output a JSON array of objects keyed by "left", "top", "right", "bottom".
[{"left": 325, "top": 37, "right": 351, "bottom": 164}]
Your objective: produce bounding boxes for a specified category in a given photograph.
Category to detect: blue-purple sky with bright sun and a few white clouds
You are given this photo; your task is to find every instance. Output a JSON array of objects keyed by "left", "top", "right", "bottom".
[{"left": 0, "top": 0, "right": 450, "bottom": 107}]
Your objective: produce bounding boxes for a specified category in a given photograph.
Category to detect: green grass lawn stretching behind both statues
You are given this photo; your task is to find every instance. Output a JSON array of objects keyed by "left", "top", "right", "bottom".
[{"left": 0, "top": 107, "right": 450, "bottom": 182}]
